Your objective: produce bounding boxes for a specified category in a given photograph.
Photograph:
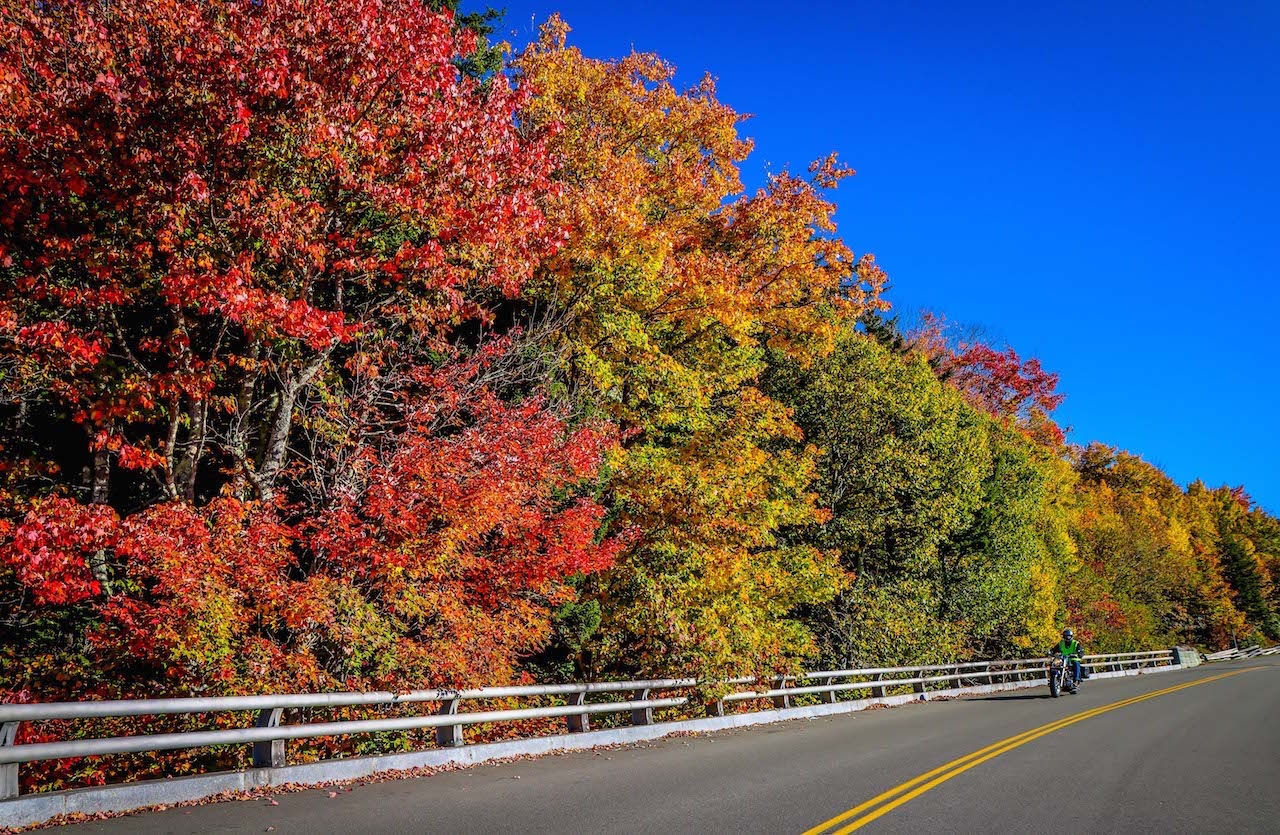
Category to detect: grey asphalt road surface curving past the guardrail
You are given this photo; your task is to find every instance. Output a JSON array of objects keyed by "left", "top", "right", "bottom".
[{"left": 55, "top": 658, "right": 1280, "bottom": 835}]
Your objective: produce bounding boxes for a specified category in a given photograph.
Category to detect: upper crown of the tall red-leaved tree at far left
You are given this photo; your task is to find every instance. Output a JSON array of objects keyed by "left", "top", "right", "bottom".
[{"left": 0, "top": 0, "right": 561, "bottom": 497}]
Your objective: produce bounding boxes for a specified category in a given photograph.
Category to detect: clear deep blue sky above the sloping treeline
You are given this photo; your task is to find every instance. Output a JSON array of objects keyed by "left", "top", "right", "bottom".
[{"left": 470, "top": 0, "right": 1280, "bottom": 512}]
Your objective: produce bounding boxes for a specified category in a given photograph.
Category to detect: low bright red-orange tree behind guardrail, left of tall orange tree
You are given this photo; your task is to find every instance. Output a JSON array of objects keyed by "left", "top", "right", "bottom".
[{"left": 300, "top": 371, "right": 621, "bottom": 683}]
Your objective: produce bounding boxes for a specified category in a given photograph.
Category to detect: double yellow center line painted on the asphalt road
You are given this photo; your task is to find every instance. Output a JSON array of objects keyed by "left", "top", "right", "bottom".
[{"left": 804, "top": 667, "right": 1262, "bottom": 835}]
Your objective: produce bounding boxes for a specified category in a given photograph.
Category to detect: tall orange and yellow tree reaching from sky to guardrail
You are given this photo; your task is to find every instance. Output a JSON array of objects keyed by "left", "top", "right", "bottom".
[{"left": 516, "top": 18, "right": 883, "bottom": 676}]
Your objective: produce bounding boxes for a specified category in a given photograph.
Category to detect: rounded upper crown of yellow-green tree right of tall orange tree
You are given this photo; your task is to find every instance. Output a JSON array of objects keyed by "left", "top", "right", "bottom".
[{"left": 771, "top": 330, "right": 991, "bottom": 581}]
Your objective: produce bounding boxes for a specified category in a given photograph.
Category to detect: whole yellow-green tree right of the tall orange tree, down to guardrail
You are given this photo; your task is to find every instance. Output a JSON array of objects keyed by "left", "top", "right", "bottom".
[{"left": 768, "top": 329, "right": 991, "bottom": 663}]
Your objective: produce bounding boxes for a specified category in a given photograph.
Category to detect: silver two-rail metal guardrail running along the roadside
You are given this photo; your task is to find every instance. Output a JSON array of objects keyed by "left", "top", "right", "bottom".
[{"left": 0, "top": 651, "right": 1175, "bottom": 800}]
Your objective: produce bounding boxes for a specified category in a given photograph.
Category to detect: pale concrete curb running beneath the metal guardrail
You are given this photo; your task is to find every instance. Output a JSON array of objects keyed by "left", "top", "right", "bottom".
[{"left": 0, "top": 665, "right": 1181, "bottom": 829}]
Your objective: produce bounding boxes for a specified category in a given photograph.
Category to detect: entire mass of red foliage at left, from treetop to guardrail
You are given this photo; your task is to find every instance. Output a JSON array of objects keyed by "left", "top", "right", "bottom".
[{"left": 0, "top": 0, "right": 616, "bottom": 737}]
